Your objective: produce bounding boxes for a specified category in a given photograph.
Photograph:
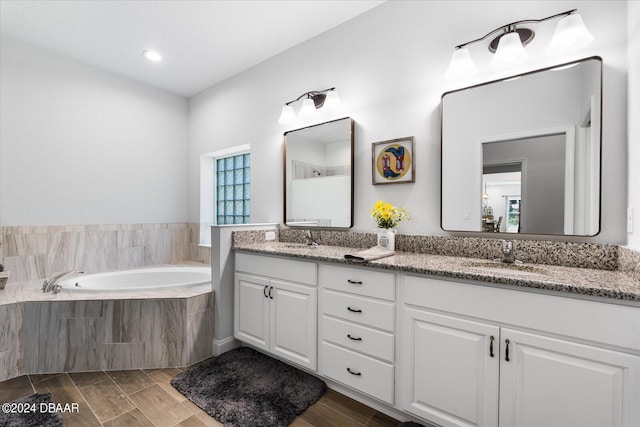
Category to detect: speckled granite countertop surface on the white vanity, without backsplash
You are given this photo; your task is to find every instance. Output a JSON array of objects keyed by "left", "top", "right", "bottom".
[{"left": 233, "top": 242, "right": 640, "bottom": 306}]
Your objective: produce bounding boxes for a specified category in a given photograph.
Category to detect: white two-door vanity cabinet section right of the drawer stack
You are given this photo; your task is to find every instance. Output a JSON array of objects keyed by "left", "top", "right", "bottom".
[{"left": 401, "top": 276, "right": 640, "bottom": 426}]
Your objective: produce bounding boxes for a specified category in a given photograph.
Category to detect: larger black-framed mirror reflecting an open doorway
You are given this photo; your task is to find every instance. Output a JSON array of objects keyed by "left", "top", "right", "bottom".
[{"left": 441, "top": 57, "right": 602, "bottom": 236}]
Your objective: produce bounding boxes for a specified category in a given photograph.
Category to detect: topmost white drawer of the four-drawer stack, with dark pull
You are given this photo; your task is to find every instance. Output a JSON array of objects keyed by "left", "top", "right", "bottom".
[{"left": 318, "top": 265, "right": 396, "bottom": 301}]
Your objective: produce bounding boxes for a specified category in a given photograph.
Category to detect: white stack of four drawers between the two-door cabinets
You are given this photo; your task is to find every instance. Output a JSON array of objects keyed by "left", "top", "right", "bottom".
[{"left": 318, "top": 264, "right": 396, "bottom": 405}]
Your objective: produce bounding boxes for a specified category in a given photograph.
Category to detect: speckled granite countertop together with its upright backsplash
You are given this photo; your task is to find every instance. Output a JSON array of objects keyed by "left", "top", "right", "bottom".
[{"left": 234, "top": 230, "right": 640, "bottom": 304}]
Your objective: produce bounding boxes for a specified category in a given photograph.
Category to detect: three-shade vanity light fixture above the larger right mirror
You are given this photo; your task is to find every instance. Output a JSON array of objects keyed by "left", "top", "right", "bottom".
[{"left": 445, "top": 9, "right": 593, "bottom": 79}]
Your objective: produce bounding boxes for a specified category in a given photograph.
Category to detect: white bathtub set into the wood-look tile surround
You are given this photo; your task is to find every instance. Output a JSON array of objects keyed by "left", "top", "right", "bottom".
[{"left": 58, "top": 267, "right": 211, "bottom": 292}]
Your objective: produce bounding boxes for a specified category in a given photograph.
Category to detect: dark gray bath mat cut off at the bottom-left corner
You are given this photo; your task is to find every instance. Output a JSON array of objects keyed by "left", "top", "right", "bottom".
[{"left": 0, "top": 393, "right": 64, "bottom": 427}]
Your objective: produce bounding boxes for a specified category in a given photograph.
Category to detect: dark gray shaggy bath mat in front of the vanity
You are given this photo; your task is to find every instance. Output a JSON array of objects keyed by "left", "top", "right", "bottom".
[{"left": 171, "top": 347, "right": 326, "bottom": 427}]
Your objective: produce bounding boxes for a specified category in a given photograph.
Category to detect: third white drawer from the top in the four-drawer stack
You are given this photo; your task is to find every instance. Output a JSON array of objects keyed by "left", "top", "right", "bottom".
[{"left": 321, "top": 316, "right": 394, "bottom": 363}]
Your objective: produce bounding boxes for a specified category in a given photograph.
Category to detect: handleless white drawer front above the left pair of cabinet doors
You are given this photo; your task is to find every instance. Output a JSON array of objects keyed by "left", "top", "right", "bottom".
[{"left": 235, "top": 253, "right": 318, "bottom": 286}]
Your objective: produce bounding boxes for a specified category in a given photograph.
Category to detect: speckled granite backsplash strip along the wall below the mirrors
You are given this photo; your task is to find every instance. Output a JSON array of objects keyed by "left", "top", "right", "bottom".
[{"left": 234, "top": 229, "right": 616, "bottom": 270}]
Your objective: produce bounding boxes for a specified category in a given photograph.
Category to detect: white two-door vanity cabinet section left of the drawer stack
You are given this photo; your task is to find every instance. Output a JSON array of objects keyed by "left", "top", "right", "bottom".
[{"left": 234, "top": 253, "right": 317, "bottom": 371}]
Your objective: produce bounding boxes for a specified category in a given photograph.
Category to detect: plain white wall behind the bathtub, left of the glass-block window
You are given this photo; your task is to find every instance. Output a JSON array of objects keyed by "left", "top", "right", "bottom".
[{"left": 0, "top": 39, "right": 189, "bottom": 226}]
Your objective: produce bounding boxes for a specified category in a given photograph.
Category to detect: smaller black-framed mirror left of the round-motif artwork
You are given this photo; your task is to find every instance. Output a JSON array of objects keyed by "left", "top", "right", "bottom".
[{"left": 284, "top": 117, "right": 354, "bottom": 228}]
